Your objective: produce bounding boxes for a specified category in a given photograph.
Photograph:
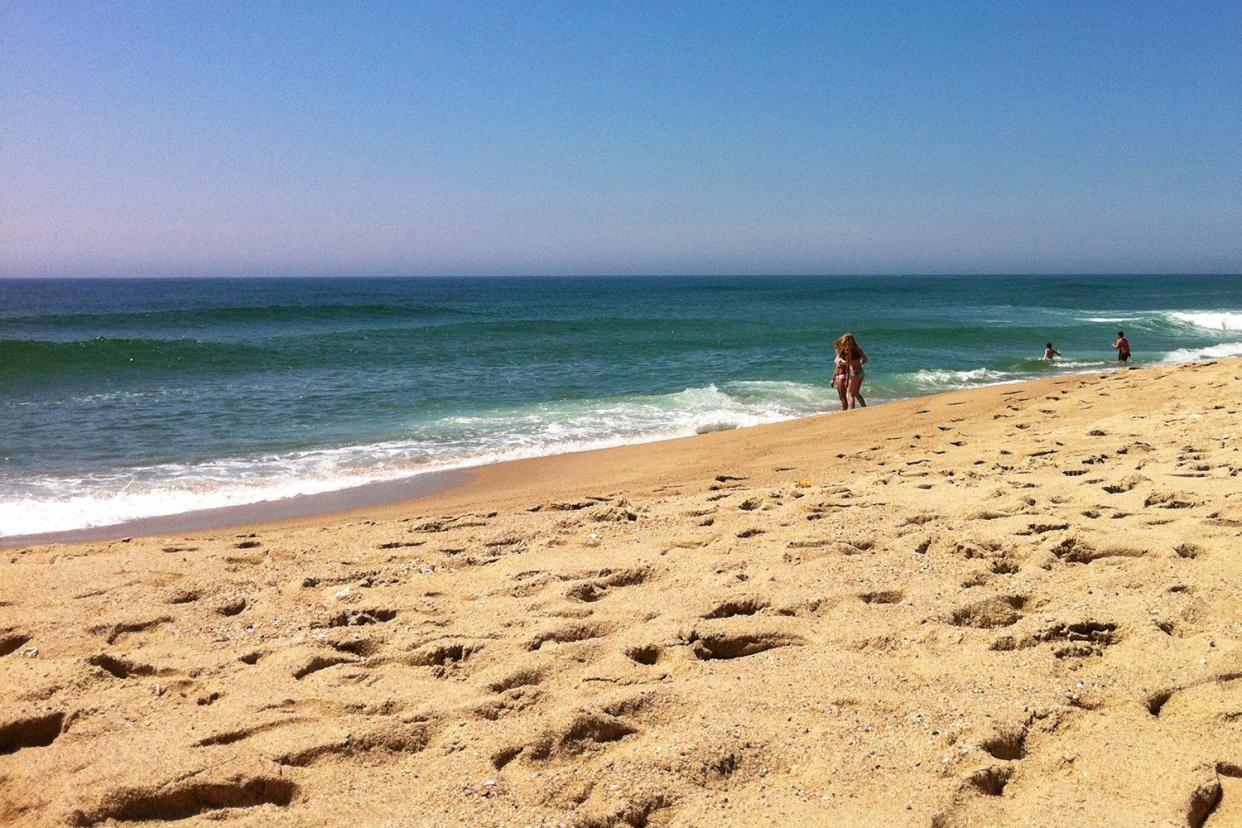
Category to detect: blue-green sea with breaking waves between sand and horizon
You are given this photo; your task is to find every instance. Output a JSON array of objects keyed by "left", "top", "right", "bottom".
[{"left": 0, "top": 276, "right": 1242, "bottom": 535}]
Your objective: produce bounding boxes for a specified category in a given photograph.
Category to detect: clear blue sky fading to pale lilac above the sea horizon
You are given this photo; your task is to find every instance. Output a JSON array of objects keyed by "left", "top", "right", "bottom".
[{"left": 0, "top": 0, "right": 1242, "bottom": 276}]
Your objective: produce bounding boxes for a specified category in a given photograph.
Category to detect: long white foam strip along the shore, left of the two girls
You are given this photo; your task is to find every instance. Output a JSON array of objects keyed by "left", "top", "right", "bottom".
[{"left": 0, "top": 382, "right": 836, "bottom": 536}]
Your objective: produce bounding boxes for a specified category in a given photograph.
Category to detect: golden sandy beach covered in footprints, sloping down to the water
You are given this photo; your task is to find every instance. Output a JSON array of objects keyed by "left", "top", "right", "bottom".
[{"left": 0, "top": 360, "right": 1242, "bottom": 828}]
